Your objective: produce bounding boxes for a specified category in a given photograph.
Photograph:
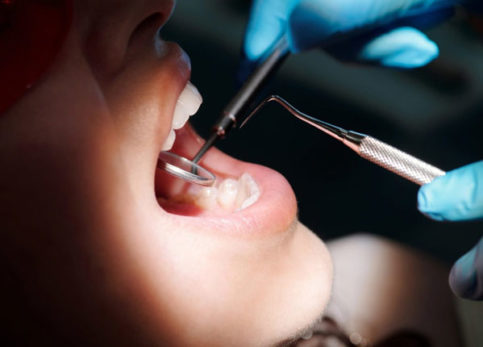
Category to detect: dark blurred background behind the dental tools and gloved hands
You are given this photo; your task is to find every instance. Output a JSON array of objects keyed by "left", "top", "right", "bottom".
[{"left": 163, "top": 0, "right": 483, "bottom": 263}]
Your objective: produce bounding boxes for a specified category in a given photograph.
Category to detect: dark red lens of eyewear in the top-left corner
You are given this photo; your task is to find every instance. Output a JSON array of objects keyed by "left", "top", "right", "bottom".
[{"left": 0, "top": 1, "right": 72, "bottom": 113}]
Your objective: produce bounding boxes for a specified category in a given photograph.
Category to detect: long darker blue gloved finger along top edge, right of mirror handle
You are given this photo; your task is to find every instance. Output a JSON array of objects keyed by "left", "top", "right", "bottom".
[{"left": 289, "top": 0, "right": 454, "bottom": 52}]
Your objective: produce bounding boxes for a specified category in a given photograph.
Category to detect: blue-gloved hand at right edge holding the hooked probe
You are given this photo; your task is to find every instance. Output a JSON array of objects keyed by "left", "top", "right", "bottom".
[{"left": 418, "top": 161, "right": 483, "bottom": 300}]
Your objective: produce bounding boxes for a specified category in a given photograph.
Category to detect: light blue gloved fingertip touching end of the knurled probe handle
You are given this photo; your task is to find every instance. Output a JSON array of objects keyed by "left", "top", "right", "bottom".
[{"left": 418, "top": 161, "right": 483, "bottom": 221}]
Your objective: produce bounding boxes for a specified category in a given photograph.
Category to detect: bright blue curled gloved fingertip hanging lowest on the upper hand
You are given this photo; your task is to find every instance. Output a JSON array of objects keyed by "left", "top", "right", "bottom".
[{"left": 356, "top": 27, "right": 439, "bottom": 69}]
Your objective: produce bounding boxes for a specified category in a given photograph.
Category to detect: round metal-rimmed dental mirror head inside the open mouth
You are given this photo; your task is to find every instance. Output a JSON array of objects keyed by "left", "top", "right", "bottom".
[{"left": 157, "top": 152, "right": 216, "bottom": 186}]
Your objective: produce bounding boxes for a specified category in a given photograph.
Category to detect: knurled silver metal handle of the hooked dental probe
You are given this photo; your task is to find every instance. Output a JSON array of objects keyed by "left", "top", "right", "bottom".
[{"left": 359, "top": 136, "right": 446, "bottom": 185}]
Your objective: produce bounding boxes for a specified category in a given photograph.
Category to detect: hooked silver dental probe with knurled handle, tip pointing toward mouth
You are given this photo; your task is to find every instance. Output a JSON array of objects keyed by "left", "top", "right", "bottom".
[{"left": 244, "top": 95, "right": 446, "bottom": 185}]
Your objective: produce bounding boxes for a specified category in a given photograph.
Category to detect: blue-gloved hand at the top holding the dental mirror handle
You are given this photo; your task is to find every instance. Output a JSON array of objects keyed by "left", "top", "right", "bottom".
[{"left": 244, "top": 0, "right": 463, "bottom": 68}]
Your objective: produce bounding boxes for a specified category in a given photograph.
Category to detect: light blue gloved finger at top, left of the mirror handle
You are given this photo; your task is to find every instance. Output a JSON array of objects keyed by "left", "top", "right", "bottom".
[{"left": 244, "top": 0, "right": 300, "bottom": 61}]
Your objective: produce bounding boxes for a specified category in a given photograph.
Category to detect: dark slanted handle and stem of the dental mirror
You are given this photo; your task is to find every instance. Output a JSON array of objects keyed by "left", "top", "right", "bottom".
[{"left": 192, "top": 36, "right": 289, "bottom": 163}]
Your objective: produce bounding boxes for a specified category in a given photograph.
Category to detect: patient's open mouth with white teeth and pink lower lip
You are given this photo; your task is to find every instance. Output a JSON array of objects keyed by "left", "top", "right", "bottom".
[{"left": 155, "top": 82, "right": 296, "bottom": 234}]
